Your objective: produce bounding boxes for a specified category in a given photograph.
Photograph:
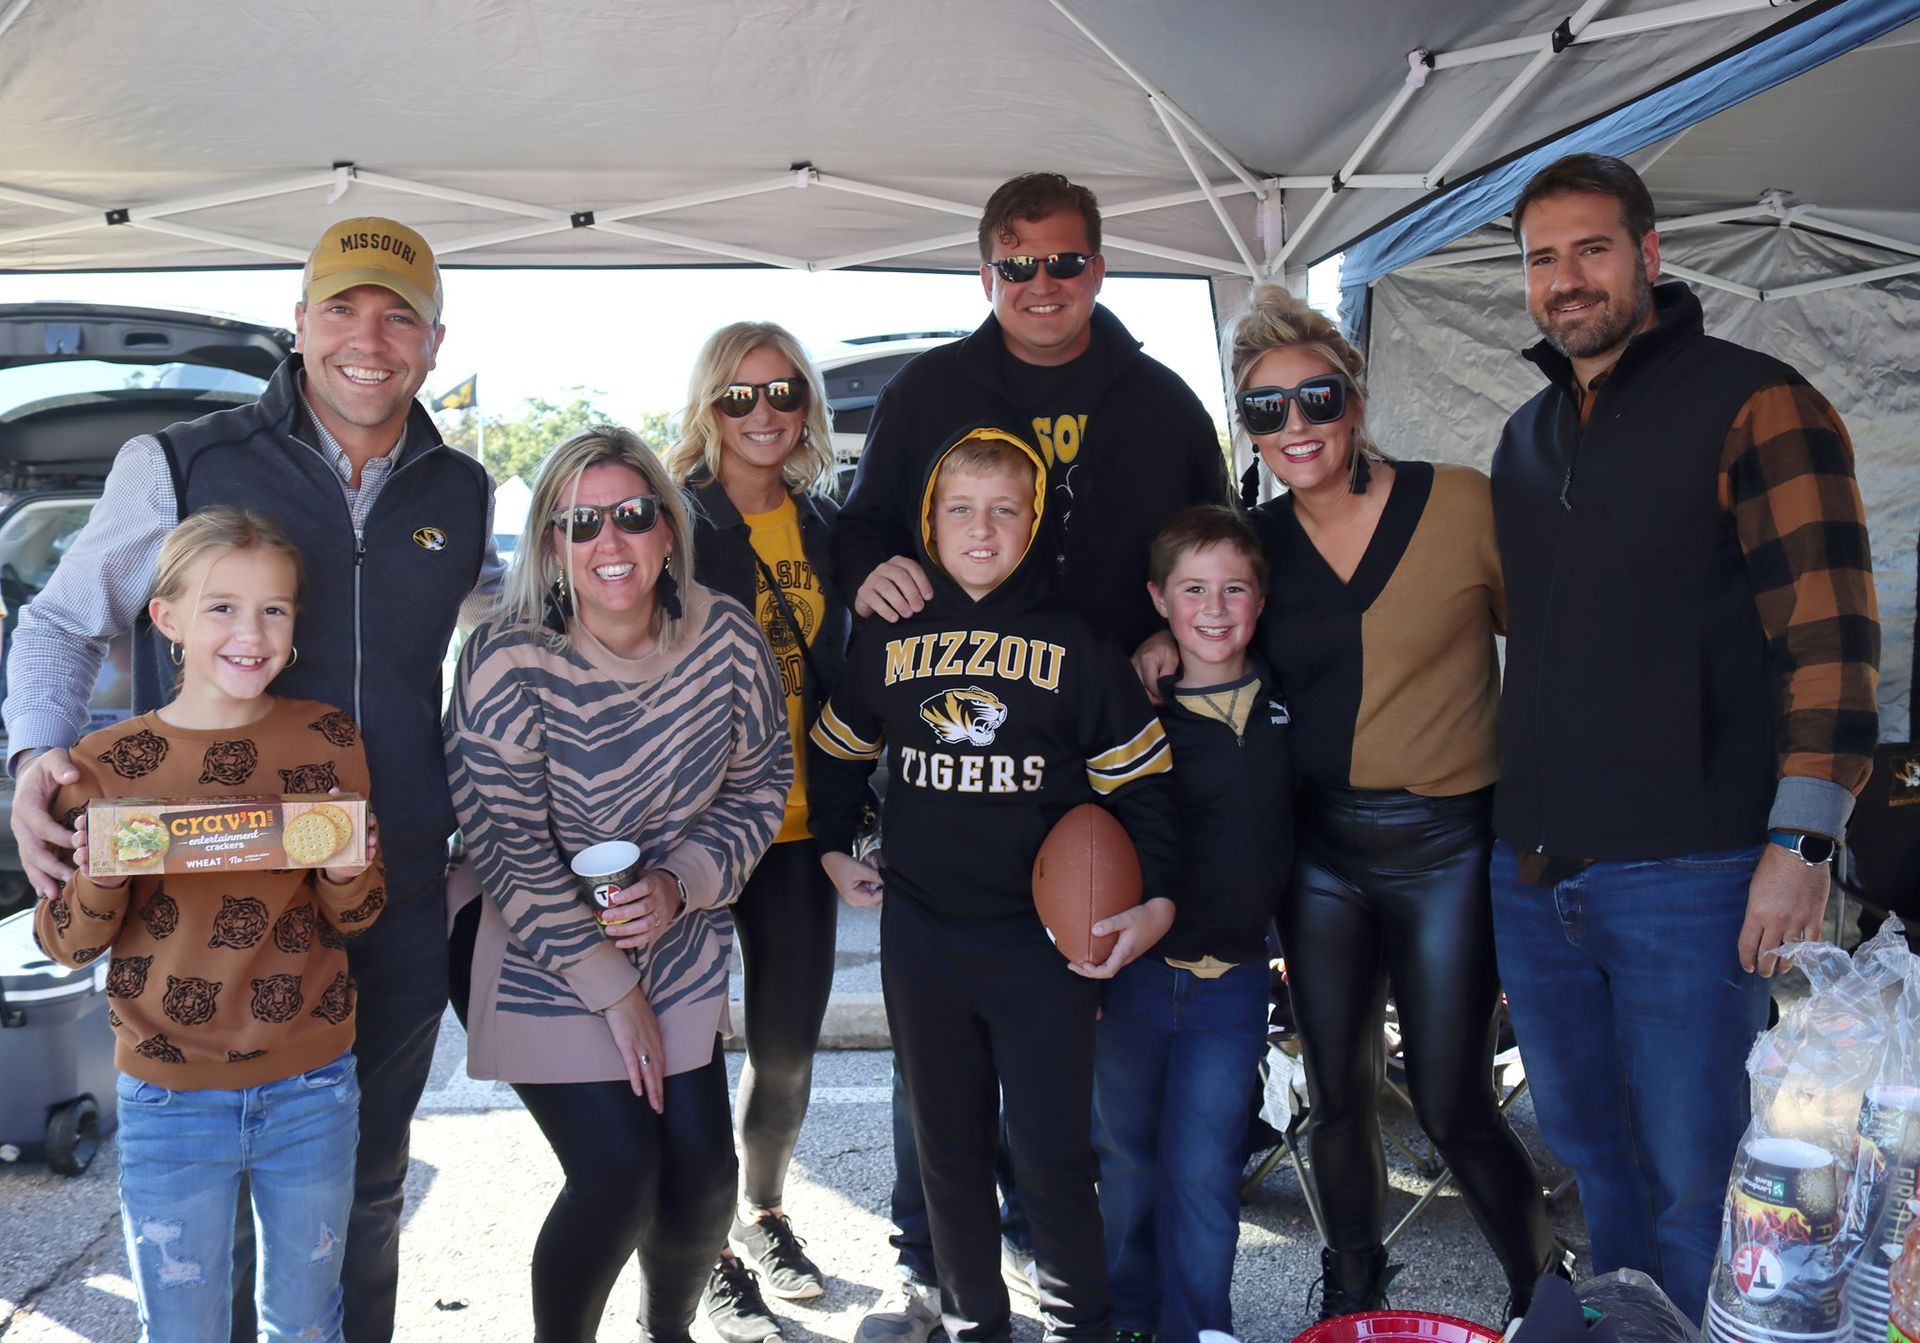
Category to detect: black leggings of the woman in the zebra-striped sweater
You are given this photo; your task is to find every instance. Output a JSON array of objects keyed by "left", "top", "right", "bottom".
[{"left": 449, "top": 903, "right": 739, "bottom": 1343}]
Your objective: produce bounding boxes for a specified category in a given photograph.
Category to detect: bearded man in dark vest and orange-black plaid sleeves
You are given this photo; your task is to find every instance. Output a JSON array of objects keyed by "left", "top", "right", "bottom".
[{"left": 1492, "top": 154, "right": 1880, "bottom": 1322}]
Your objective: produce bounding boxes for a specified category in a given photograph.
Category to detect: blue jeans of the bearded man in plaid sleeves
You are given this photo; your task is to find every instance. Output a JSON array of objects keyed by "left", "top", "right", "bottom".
[{"left": 1492, "top": 842, "right": 1768, "bottom": 1324}]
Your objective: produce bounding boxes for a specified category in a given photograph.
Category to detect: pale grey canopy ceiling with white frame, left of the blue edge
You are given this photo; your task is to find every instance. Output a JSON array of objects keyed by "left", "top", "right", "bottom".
[{"left": 0, "top": 0, "right": 1830, "bottom": 273}]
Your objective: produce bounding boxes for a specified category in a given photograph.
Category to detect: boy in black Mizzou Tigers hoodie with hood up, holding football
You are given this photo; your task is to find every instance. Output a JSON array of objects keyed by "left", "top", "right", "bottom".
[{"left": 808, "top": 428, "right": 1177, "bottom": 1341}]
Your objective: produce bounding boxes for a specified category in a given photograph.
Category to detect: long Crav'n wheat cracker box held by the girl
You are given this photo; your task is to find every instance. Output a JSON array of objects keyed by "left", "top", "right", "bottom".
[{"left": 86, "top": 794, "right": 367, "bottom": 876}]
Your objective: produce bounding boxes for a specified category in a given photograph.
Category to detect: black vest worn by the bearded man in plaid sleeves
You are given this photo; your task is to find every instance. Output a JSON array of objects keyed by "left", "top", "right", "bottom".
[{"left": 1492, "top": 284, "right": 1799, "bottom": 859}]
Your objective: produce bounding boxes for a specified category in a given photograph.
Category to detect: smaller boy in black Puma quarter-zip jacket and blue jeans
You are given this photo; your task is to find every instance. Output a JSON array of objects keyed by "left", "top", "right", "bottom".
[{"left": 1094, "top": 505, "right": 1294, "bottom": 1343}]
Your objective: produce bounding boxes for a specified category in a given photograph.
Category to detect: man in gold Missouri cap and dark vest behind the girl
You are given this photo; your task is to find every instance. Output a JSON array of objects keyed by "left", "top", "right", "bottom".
[{"left": 4, "top": 217, "right": 501, "bottom": 1343}]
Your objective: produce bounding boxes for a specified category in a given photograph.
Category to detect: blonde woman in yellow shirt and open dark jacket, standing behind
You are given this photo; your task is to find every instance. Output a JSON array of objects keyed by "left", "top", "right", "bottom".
[{"left": 666, "top": 321, "right": 849, "bottom": 1343}]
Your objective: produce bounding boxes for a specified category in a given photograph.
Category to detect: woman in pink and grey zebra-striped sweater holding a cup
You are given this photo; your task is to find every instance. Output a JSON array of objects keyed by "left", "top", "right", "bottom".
[{"left": 447, "top": 427, "right": 793, "bottom": 1343}]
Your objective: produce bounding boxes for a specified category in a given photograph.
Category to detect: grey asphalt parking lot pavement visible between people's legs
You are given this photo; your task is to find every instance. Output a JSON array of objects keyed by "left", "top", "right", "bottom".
[{"left": 0, "top": 911, "right": 1584, "bottom": 1343}]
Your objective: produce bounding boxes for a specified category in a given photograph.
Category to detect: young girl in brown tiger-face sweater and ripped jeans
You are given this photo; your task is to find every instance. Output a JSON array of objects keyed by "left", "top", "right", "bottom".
[{"left": 35, "top": 509, "right": 386, "bottom": 1343}]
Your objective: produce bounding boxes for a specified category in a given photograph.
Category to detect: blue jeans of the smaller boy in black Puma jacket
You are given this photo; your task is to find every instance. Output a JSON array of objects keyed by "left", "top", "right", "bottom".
[{"left": 1092, "top": 955, "right": 1267, "bottom": 1343}]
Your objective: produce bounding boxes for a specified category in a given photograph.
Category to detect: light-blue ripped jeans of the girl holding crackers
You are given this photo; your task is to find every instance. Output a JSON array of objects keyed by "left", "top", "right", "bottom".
[{"left": 117, "top": 1053, "right": 359, "bottom": 1343}]
